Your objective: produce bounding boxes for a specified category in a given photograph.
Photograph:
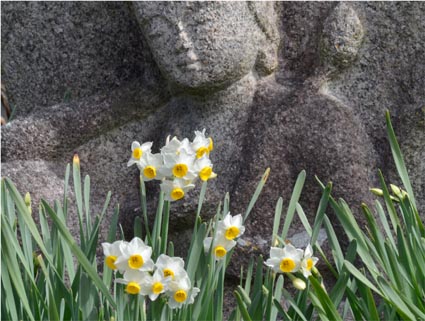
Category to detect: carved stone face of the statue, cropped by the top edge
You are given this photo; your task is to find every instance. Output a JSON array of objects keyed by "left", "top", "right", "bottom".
[{"left": 133, "top": 1, "right": 264, "bottom": 92}]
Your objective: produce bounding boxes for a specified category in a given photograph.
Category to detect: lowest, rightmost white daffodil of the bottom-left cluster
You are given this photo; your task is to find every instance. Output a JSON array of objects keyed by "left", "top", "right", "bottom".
[{"left": 167, "top": 276, "right": 199, "bottom": 309}]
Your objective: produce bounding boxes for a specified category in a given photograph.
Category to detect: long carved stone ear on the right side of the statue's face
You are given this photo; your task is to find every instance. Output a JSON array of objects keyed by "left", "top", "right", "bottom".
[{"left": 248, "top": 1, "right": 280, "bottom": 76}]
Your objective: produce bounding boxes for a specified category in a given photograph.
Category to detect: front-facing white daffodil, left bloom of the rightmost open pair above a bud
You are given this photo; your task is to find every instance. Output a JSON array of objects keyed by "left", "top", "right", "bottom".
[{"left": 265, "top": 244, "right": 303, "bottom": 273}]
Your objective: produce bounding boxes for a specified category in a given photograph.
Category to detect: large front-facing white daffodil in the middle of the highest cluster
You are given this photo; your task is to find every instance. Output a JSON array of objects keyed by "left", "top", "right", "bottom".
[{"left": 161, "top": 148, "right": 197, "bottom": 180}]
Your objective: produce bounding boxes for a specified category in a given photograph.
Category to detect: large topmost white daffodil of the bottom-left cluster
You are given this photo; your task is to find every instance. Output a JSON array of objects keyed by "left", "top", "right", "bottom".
[{"left": 115, "top": 237, "right": 154, "bottom": 271}]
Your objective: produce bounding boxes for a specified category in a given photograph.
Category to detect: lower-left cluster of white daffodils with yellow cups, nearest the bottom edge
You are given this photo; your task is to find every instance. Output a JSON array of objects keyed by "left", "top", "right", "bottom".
[{"left": 102, "top": 237, "right": 199, "bottom": 309}]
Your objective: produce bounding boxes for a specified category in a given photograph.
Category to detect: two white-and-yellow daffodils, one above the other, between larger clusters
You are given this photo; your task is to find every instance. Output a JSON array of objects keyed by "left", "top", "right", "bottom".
[{"left": 204, "top": 213, "right": 245, "bottom": 260}]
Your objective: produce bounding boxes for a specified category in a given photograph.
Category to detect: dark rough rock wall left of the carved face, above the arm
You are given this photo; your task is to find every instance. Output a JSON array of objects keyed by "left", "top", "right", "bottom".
[{"left": 1, "top": 1, "right": 161, "bottom": 117}]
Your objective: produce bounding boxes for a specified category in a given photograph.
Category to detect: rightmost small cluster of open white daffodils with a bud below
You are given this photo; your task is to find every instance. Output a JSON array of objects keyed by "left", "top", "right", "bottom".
[{"left": 265, "top": 244, "right": 319, "bottom": 290}]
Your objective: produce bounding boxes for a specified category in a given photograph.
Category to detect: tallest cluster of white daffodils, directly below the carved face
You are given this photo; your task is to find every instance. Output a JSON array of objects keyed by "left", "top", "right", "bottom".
[{"left": 127, "top": 129, "right": 217, "bottom": 201}]
